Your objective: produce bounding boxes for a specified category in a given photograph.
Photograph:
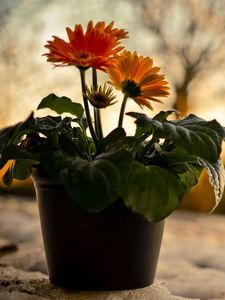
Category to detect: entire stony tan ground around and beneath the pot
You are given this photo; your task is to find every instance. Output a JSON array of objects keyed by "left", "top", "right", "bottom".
[{"left": 0, "top": 197, "right": 225, "bottom": 300}]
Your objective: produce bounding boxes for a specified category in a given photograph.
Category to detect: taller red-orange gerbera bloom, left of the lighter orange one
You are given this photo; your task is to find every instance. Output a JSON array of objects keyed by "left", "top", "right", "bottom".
[{"left": 44, "top": 21, "right": 127, "bottom": 70}]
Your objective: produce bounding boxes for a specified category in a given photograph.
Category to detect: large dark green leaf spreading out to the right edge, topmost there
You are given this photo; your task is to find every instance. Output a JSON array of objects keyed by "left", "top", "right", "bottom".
[{"left": 129, "top": 113, "right": 225, "bottom": 162}]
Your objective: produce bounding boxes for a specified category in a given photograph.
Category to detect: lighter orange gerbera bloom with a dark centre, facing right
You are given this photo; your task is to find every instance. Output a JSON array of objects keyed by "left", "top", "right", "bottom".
[{"left": 107, "top": 51, "right": 169, "bottom": 109}]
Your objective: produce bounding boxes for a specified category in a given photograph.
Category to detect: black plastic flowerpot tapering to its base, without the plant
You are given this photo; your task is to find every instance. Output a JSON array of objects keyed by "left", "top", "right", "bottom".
[{"left": 32, "top": 169, "right": 164, "bottom": 290}]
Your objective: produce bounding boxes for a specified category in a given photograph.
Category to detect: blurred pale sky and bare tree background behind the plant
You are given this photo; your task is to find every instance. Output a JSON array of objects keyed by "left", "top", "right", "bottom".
[{"left": 0, "top": 0, "right": 225, "bottom": 213}]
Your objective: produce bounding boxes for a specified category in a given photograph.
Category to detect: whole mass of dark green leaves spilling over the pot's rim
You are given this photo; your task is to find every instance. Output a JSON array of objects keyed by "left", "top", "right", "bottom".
[{"left": 0, "top": 94, "right": 224, "bottom": 222}]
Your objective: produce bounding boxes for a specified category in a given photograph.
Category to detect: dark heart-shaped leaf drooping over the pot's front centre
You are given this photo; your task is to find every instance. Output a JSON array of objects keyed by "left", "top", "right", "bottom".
[{"left": 61, "top": 150, "right": 132, "bottom": 213}]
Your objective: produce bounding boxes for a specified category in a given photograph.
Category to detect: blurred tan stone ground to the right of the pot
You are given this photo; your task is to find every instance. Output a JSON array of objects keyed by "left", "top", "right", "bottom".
[{"left": 157, "top": 211, "right": 225, "bottom": 299}]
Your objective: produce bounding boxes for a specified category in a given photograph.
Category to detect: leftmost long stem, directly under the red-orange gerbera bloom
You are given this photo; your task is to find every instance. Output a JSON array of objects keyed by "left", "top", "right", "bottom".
[{"left": 80, "top": 69, "right": 98, "bottom": 145}]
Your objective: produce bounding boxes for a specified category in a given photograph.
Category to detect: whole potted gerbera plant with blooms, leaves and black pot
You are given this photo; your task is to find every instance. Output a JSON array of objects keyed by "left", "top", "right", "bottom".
[{"left": 0, "top": 21, "right": 224, "bottom": 290}]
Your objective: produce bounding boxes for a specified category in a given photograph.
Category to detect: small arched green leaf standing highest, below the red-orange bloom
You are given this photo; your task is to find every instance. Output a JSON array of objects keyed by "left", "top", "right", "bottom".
[{"left": 37, "top": 94, "right": 84, "bottom": 118}]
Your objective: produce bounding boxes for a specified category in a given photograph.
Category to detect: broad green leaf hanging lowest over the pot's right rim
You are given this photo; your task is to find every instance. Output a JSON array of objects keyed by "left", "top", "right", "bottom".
[{"left": 124, "top": 161, "right": 187, "bottom": 223}]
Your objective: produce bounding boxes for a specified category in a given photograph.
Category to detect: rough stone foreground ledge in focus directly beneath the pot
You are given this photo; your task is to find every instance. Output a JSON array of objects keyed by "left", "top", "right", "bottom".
[{"left": 0, "top": 266, "right": 193, "bottom": 300}]
